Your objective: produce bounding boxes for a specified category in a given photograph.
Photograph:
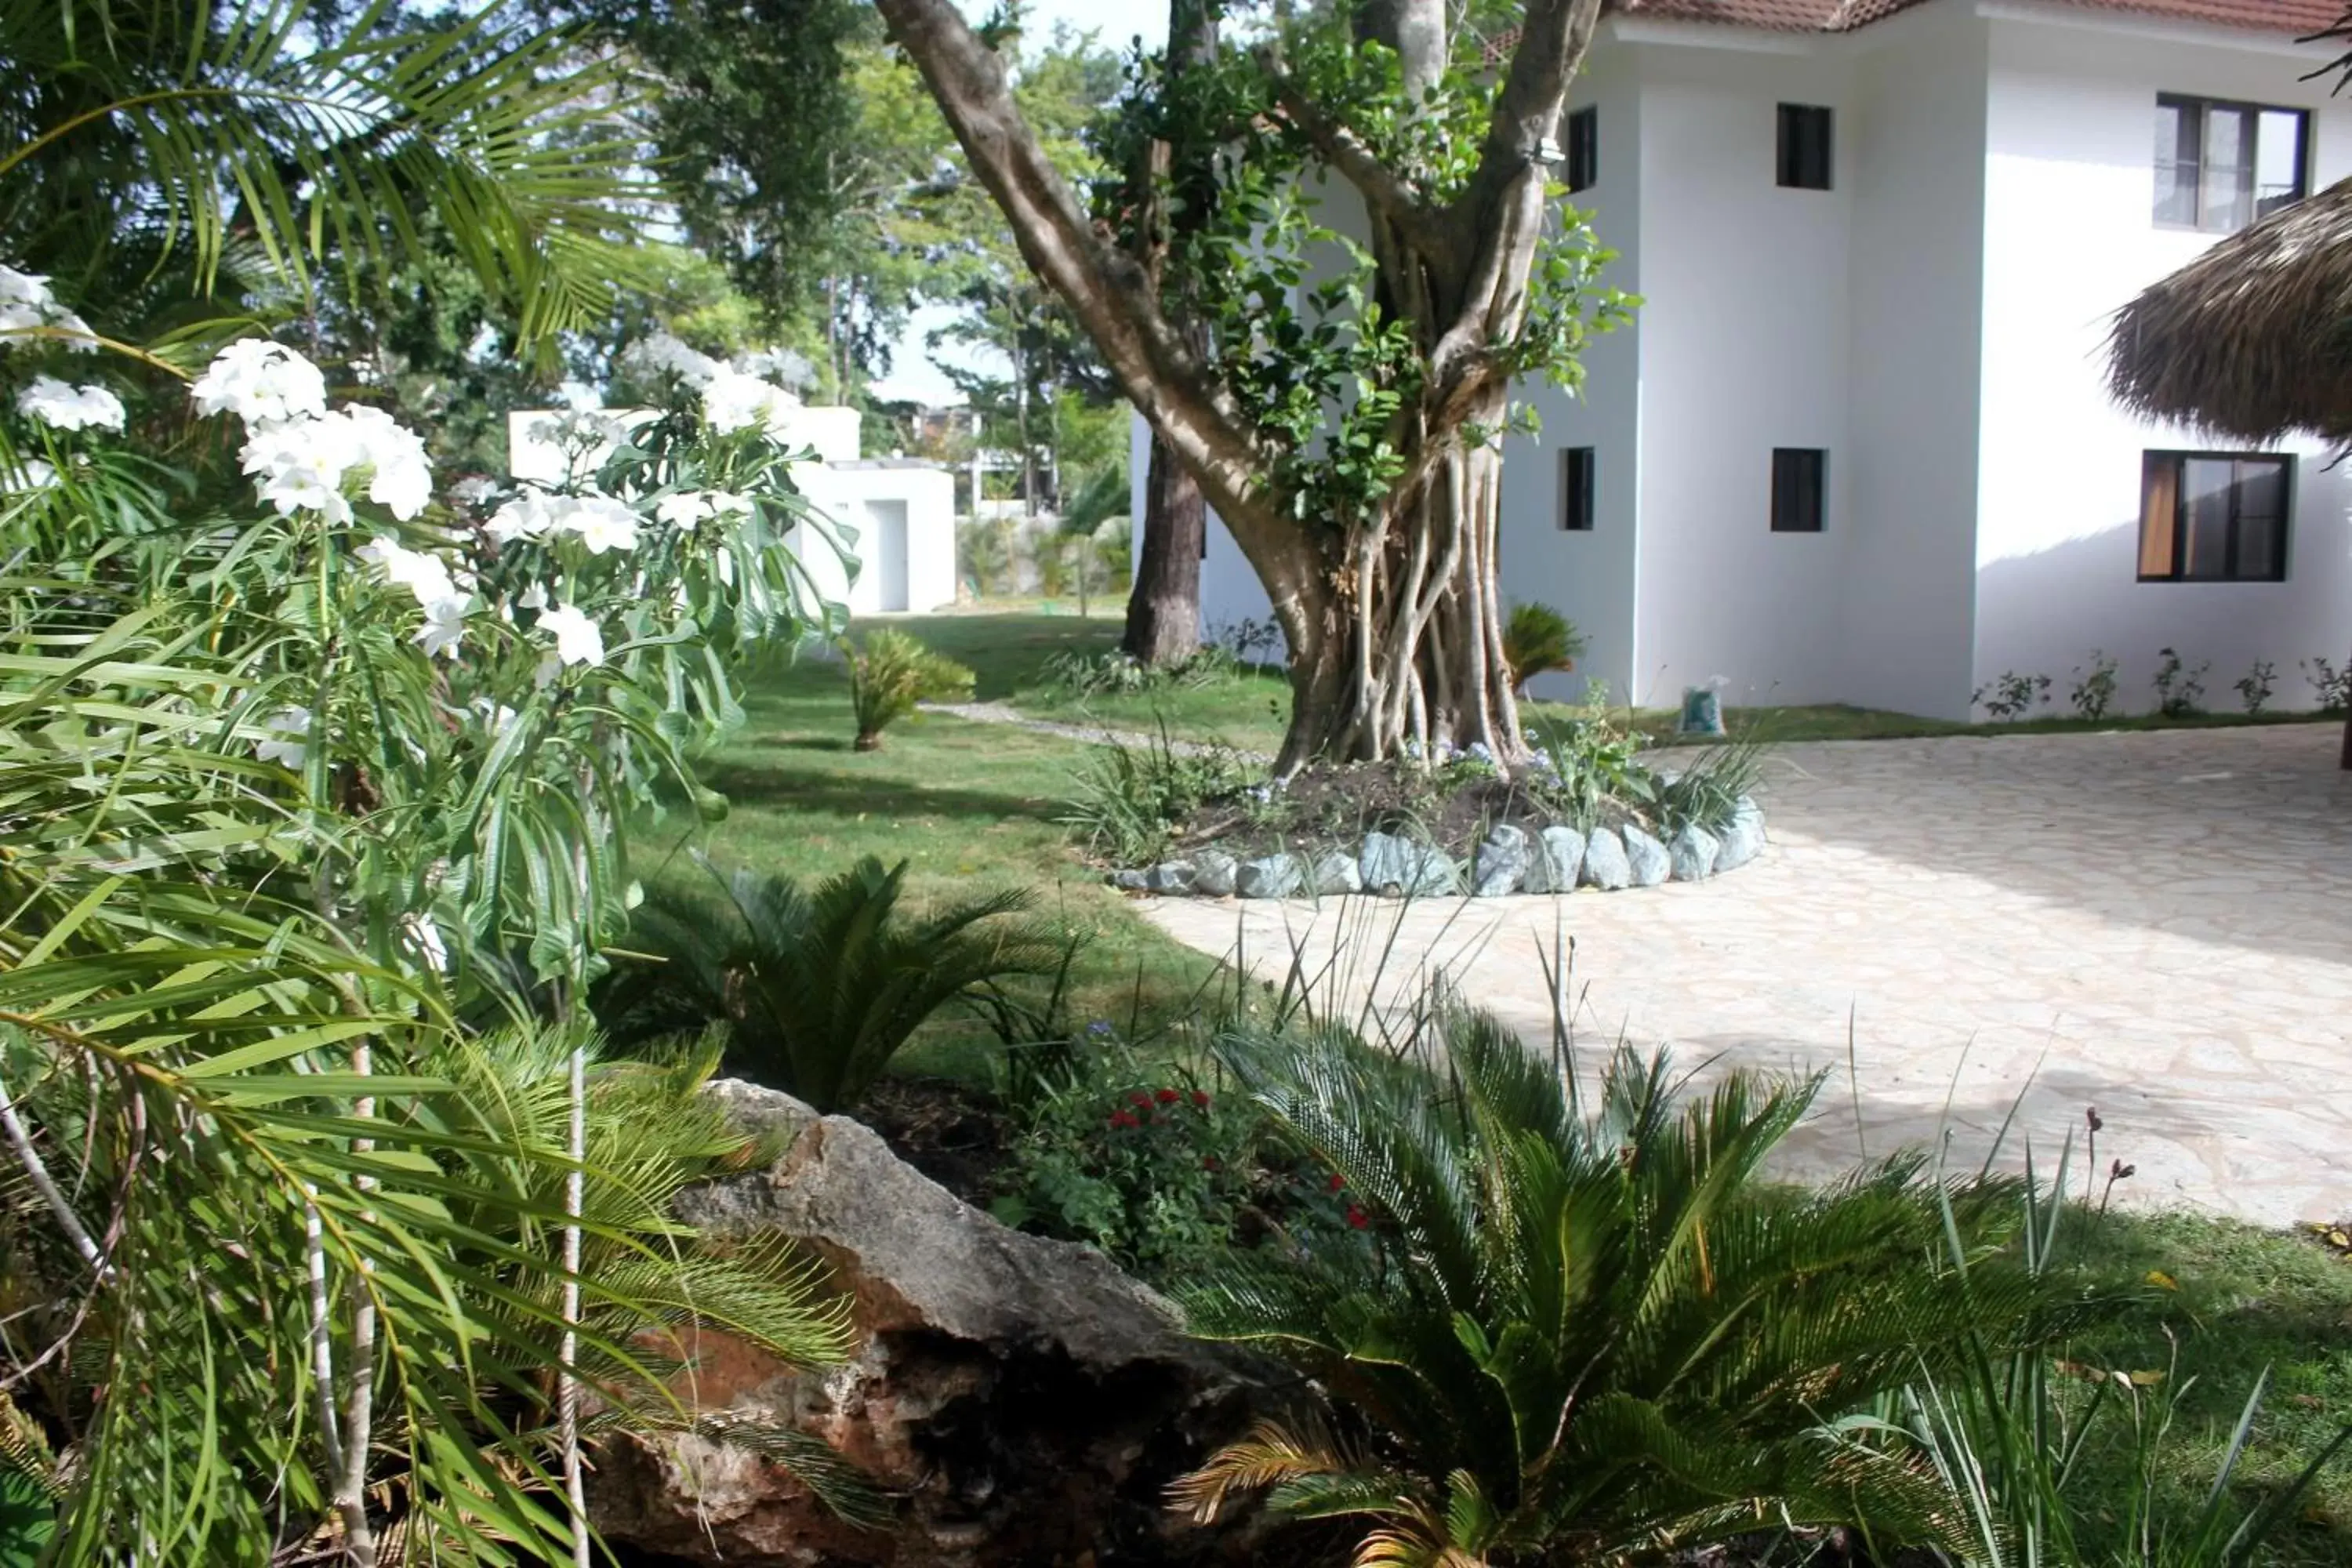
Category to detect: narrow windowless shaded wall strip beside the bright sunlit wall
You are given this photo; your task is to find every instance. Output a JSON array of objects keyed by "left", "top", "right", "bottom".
[{"left": 1830, "top": 5, "right": 1987, "bottom": 720}]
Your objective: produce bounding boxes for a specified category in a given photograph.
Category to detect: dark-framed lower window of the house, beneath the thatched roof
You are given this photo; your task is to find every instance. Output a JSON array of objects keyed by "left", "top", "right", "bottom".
[{"left": 2140, "top": 452, "right": 2296, "bottom": 583}]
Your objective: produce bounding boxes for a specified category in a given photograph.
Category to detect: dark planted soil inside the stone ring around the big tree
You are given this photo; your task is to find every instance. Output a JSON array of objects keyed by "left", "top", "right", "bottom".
[{"left": 1178, "top": 767, "right": 1632, "bottom": 860}]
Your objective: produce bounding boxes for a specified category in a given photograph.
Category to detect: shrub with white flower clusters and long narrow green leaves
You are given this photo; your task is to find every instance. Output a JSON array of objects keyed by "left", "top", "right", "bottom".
[{"left": 0, "top": 310, "right": 844, "bottom": 985}]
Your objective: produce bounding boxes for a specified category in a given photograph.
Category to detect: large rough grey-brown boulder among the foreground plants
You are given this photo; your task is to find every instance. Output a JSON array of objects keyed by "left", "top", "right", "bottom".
[{"left": 590, "top": 1081, "right": 1279, "bottom": 1568}]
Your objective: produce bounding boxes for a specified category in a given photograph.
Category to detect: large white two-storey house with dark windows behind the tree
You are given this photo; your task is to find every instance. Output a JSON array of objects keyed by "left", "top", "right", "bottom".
[{"left": 1185, "top": 0, "right": 2352, "bottom": 717}]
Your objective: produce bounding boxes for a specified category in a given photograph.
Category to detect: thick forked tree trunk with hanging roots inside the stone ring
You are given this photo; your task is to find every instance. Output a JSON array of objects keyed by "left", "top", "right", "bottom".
[{"left": 877, "top": 0, "right": 1599, "bottom": 774}]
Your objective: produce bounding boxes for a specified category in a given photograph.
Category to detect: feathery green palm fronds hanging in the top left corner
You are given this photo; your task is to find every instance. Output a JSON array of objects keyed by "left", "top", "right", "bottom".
[{"left": 0, "top": 0, "right": 647, "bottom": 343}]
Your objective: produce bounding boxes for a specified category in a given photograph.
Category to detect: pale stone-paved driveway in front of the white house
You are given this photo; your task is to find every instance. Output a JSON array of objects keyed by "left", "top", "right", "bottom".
[{"left": 1148, "top": 724, "right": 2352, "bottom": 1225}]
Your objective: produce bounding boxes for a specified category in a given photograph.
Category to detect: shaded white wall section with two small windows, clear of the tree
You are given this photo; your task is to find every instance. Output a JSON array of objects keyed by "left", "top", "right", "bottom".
[{"left": 1592, "top": 28, "right": 1856, "bottom": 706}]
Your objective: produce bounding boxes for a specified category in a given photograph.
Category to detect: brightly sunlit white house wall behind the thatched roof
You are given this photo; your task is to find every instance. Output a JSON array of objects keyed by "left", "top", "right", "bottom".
[{"left": 1973, "top": 7, "right": 2352, "bottom": 710}]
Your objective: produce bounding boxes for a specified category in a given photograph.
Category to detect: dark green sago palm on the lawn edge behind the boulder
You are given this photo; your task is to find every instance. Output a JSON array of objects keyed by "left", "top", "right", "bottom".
[{"left": 600, "top": 855, "right": 1061, "bottom": 1112}]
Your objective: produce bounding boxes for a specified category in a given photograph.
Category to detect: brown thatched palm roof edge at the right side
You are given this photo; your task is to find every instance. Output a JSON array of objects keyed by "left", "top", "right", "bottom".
[{"left": 2107, "top": 179, "right": 2352, "bottom": 447}]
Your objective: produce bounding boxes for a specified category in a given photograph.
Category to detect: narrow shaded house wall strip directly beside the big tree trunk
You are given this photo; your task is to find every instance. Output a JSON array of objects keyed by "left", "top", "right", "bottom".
[{"left": 1501, "top": 38, "right": 1642, "bottom": 703}]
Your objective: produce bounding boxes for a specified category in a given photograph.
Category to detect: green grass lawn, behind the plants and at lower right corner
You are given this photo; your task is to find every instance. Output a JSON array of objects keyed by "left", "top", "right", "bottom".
[{"left": 687, "top": 607, "right": 2352, "bottom": 1542}]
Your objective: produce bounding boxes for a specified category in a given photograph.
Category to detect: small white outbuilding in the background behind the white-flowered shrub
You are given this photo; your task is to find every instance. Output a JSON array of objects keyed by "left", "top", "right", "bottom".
[{"left": 506, "top": 407, "right": 955, "bottom": 616}]
